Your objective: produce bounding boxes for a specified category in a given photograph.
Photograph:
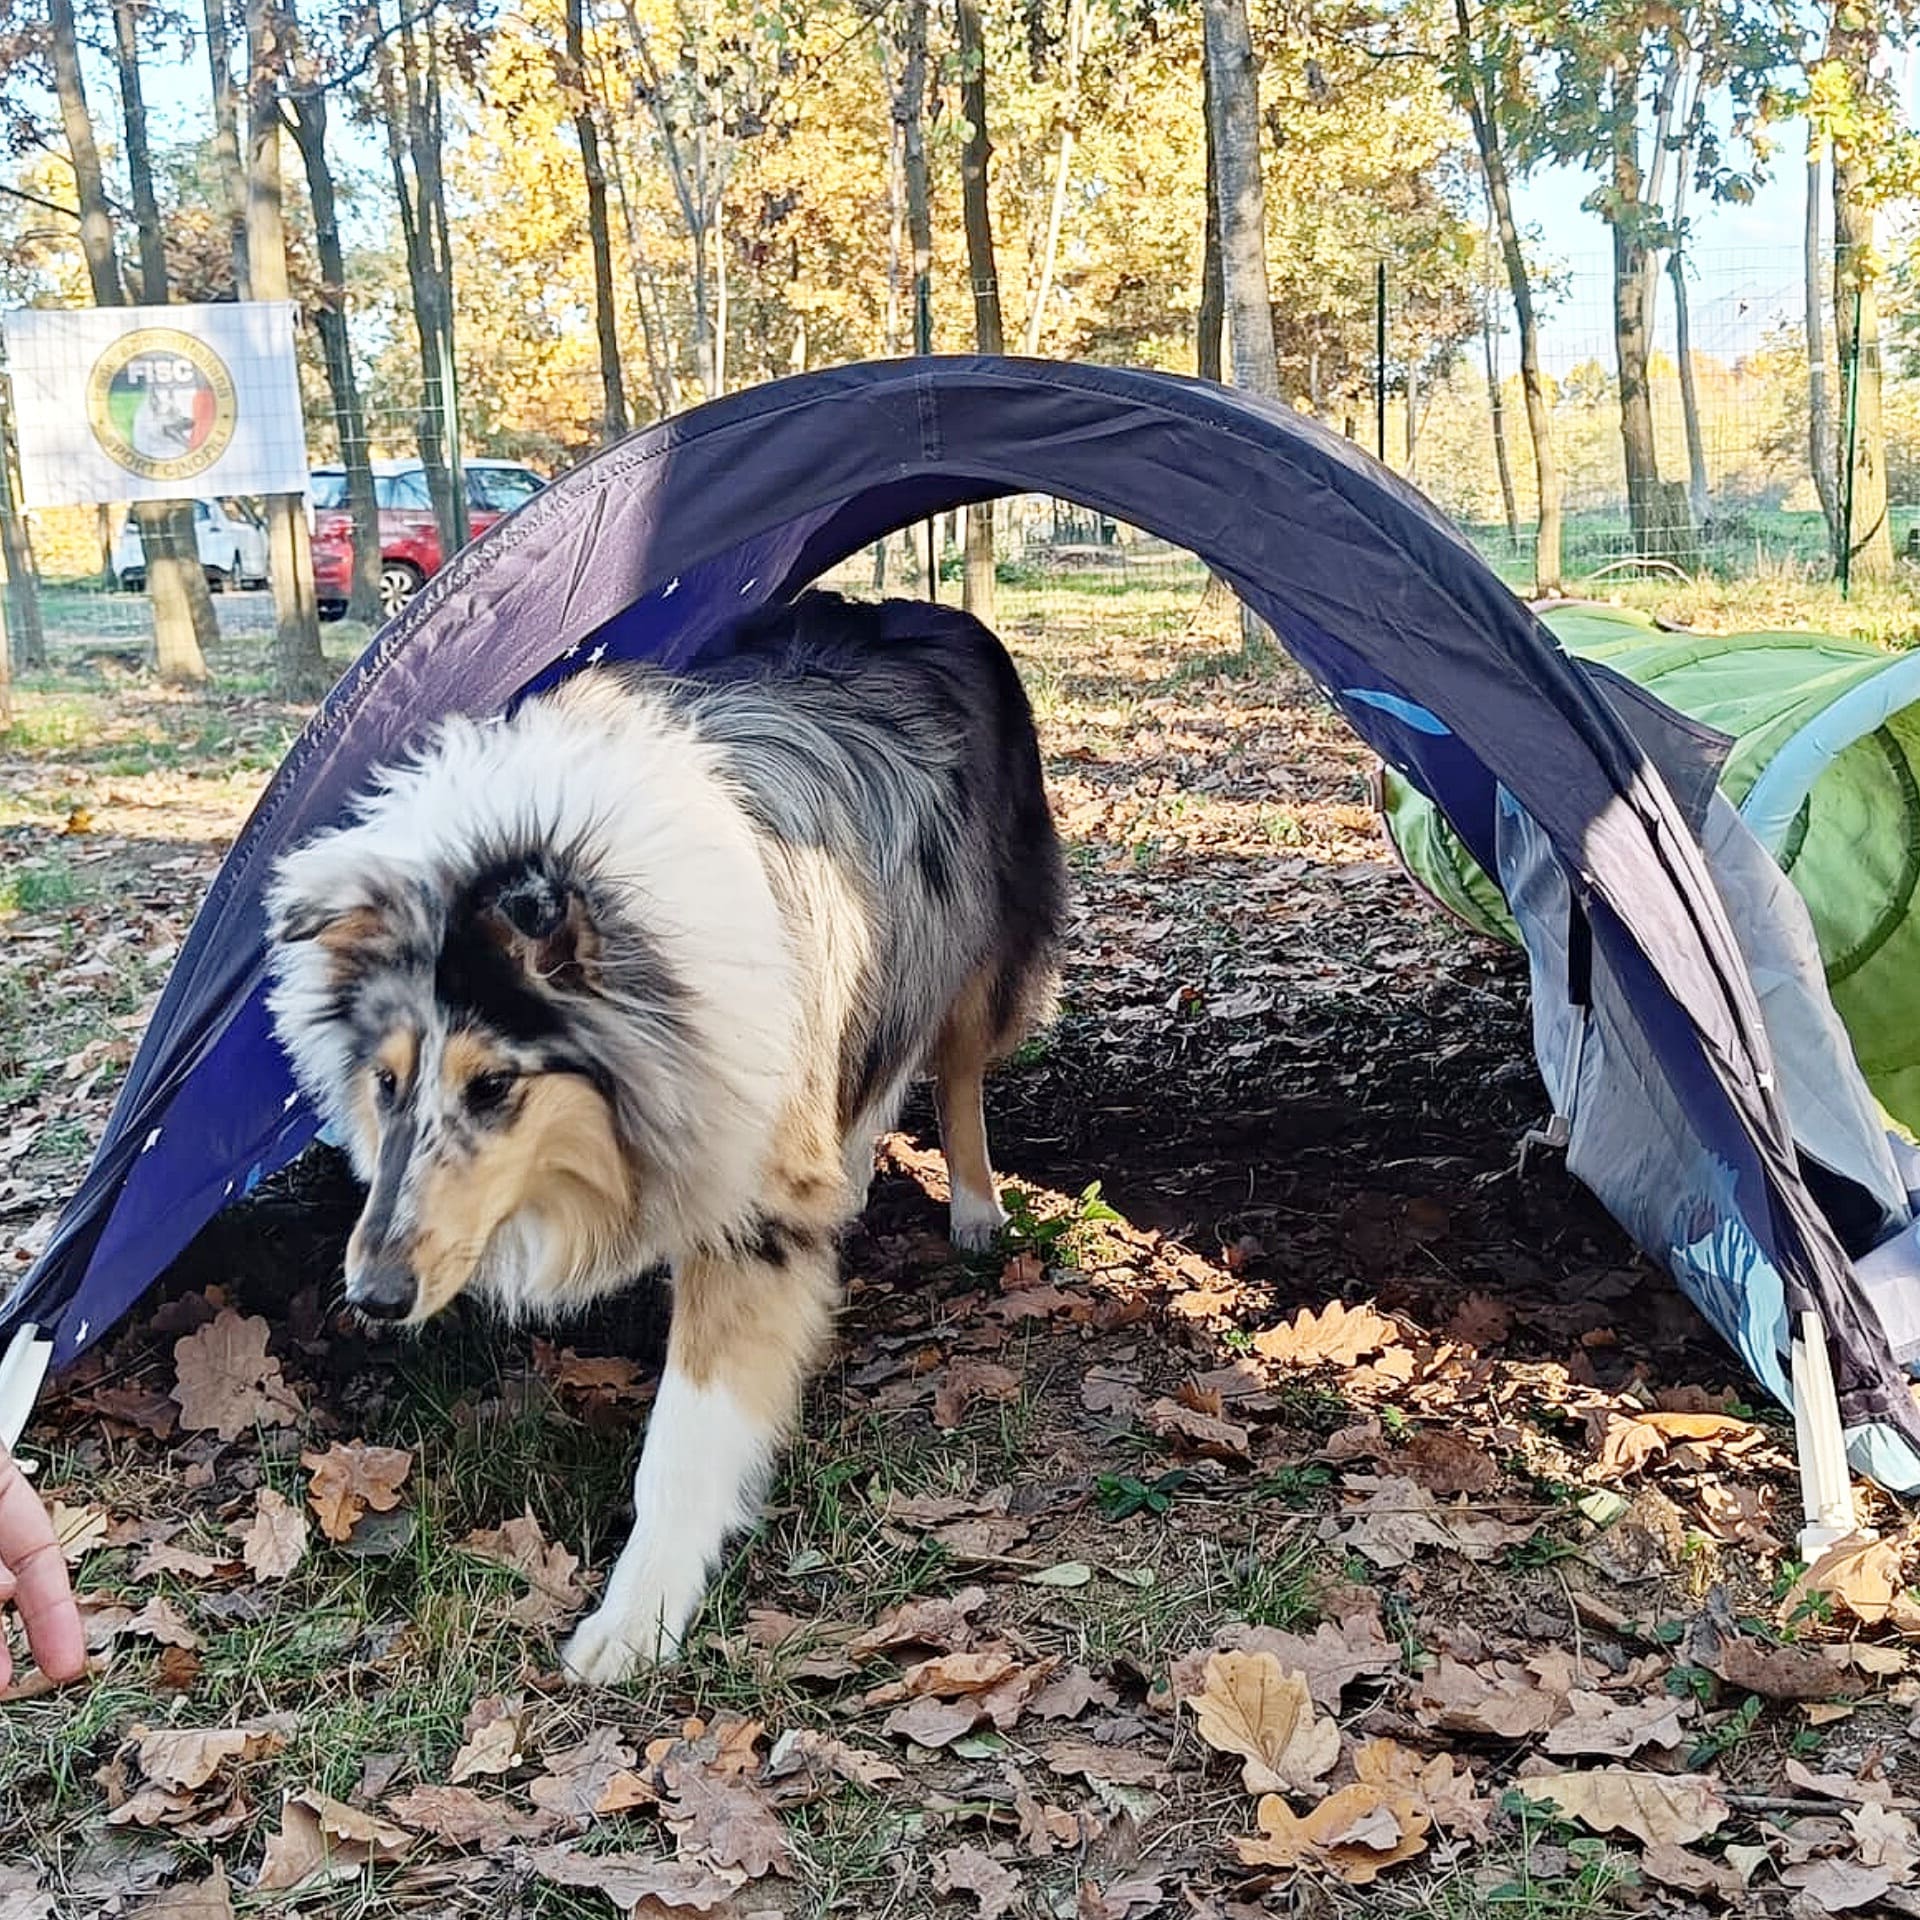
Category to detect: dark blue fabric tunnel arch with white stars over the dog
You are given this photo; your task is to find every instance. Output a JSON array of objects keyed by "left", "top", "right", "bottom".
[{"left": 0, "top": 359, "right": 1920, "bottom": 1526}]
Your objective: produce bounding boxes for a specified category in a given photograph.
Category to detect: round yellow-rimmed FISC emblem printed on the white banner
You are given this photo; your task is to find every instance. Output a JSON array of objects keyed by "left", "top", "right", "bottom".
[{"left": 86, "top": 326, "right": 238, "bottom": 480}]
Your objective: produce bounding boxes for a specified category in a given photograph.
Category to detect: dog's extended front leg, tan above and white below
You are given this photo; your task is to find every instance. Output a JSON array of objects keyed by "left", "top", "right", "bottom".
[{"left": 561, "top": 1217, "right": 839, "bottom": 1686}]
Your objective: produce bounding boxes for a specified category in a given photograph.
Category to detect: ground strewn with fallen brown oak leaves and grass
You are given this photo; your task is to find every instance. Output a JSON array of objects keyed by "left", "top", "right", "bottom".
[{"left": 0, "top": 574, "right": 1920, "bottom": 1920}]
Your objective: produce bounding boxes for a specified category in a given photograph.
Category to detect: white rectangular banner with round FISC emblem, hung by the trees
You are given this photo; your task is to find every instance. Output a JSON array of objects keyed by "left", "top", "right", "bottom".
[{"left": 6, "top": 300, "right": 307, "bottom": 507}]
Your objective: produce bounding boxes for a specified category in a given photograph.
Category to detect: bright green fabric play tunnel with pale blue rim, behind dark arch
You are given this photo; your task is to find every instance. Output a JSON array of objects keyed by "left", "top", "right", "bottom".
[{"left": 1380, "top": 607, "right": 1920, "bottom": 1135}]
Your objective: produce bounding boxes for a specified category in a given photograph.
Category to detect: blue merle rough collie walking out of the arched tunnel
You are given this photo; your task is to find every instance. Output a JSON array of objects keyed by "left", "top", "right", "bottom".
[{"left": 269, "top": 593, "right": 1064, "bottom": 1682}]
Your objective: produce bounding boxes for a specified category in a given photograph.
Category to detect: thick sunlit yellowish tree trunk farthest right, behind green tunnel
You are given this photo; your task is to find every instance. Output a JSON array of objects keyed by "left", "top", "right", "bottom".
[{"left": 1826, "top": 8, "right": 1893, "bottom": 582}]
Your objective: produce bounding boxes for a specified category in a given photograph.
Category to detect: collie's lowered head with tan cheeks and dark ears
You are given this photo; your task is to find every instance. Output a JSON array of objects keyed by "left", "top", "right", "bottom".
[{"left": 269, "top": 848, "right": 634, "bottom": 1323}]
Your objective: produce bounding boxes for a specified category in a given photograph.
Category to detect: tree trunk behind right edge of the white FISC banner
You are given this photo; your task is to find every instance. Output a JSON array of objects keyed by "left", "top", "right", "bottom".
[{"left": 246, "top": 0, "right": 330, "bottom": 699}]
